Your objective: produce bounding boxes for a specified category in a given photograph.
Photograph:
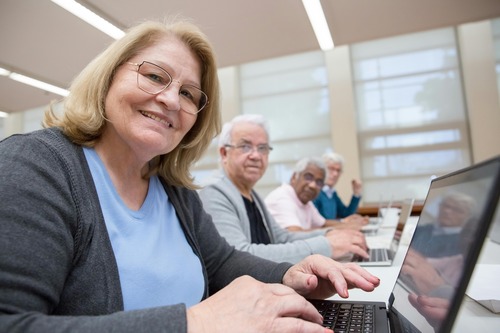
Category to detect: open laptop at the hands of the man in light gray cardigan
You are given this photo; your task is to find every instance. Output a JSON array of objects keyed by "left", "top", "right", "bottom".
[{"left": 352, "top": 199, "right": 415, "bottom": 266}]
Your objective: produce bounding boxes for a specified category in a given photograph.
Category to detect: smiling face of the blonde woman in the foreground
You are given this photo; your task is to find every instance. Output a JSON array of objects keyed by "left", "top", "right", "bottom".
[{"left": 105, "top": 36, "right": 203, "bottom": 162}]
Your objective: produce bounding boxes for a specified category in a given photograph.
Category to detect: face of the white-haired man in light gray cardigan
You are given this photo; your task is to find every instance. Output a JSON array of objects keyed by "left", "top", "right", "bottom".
[{"left": 220, "top": 123, "right": 269, "bottom": 189}]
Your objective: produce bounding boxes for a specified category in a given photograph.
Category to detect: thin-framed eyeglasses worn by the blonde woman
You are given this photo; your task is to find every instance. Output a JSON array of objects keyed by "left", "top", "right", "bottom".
[{"left": 128, "top": 61, "right": 208, "bottom": 114}]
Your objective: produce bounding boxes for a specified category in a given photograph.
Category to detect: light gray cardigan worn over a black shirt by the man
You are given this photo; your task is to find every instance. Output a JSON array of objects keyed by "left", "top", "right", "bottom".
[{"left": 200, "top": 176, "right": 332, "bottom": 263}]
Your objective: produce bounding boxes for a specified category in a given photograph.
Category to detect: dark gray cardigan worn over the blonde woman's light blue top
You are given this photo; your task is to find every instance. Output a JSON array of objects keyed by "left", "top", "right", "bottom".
[{"left": 0, "top": 129, "right": 291, "bottom": 333}]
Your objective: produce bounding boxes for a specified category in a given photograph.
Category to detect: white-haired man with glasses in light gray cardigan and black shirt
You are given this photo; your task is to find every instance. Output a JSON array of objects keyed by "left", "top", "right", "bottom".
[{"left": 200, "top": 115, "right": 368, "bottom": 263}]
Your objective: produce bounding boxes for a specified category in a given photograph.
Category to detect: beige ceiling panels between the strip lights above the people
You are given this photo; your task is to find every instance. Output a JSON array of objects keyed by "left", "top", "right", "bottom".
[{"left": 0, "top": 0, "right": 500, "bottom": 112}]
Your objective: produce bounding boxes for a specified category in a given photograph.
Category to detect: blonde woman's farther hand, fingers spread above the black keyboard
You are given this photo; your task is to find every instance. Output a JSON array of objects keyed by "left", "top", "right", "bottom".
[{"left": 283, "top": 254, "right": 380, "bottom": 299}]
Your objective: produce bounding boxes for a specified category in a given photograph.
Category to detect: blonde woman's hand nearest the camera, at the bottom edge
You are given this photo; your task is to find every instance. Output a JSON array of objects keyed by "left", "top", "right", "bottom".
[{"left": 187, "top": 276, "right": 331, "bottom": 333}]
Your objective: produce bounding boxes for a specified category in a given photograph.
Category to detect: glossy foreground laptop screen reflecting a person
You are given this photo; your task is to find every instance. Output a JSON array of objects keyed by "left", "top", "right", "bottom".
[{"left": 391, "top": 157, "right": 498, "bottom": 332}]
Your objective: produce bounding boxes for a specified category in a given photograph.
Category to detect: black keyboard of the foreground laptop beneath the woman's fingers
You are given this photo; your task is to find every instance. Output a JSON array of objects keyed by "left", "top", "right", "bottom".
[{"left": 310, "top": 300, "right": 375, "bottom": 333}]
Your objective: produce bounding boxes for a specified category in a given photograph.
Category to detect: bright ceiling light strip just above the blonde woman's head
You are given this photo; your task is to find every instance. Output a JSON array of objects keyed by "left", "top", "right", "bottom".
[{"left": 52, "top": 0, "right": 125, "bottom": 39}]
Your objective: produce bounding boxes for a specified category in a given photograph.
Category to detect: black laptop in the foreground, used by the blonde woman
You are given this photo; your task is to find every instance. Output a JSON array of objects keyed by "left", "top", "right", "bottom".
[{"left": 310, "top": 156, "right": 500, "bottom": 333}]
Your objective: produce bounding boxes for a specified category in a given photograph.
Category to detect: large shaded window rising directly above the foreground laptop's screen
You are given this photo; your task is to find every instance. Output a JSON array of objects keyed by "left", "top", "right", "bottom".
[{"left": 351, "top": 28, "right": 471, "bottom": 202}]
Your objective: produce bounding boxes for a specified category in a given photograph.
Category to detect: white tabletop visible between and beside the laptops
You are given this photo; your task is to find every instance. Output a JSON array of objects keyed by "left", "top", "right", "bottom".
[{"left": 330, "top": 216, "right": 500, "bottom": 333}]
